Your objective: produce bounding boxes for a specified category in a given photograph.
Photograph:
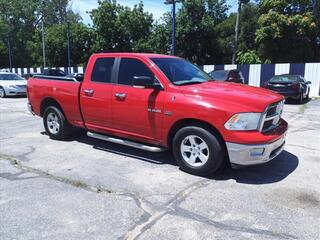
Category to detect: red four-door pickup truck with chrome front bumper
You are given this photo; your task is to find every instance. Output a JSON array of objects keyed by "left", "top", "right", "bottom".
[{"left": 27, "top": 53, "right": 288, "bottom": 175}]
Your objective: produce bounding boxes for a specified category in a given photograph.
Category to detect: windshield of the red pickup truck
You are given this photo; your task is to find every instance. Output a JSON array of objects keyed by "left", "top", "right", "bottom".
[{"left": 151, "top": 58, "right": 212, "bottom": 85}]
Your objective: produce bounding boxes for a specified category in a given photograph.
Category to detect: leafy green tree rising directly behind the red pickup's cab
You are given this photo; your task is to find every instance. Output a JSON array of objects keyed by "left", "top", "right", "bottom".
[{"left": 90, "top": 1, "right": 153, "bottom": 51}]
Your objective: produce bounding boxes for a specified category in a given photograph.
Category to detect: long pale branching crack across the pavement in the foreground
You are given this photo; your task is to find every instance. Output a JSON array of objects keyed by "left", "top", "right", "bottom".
[{"left": 0, "top": 154, "right": 296, "bottom": 240}]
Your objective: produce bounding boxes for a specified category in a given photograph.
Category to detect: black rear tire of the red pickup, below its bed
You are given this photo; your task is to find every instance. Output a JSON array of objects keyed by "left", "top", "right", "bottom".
[{"left": 43, "top": 106, "right": 72, "bottom": 140}]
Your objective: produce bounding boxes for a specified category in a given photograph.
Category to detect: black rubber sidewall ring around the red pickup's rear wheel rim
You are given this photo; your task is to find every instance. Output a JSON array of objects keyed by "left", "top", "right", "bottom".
[{"left": 43, "top": 106, "right": 69, "bottom": 140}]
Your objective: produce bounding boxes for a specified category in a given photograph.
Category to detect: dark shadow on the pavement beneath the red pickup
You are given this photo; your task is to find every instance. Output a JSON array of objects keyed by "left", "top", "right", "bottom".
[{"left": 46, "top": 130, "right": 299, "bottom": 184}]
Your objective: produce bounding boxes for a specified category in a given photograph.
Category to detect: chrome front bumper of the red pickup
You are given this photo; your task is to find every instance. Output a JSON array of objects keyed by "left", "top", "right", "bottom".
[{"left": 226, "top": 135, "right": 285, "bottom": 166}]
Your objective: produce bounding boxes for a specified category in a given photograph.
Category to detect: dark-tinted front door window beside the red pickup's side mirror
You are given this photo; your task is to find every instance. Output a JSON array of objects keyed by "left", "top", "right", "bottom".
[{"left": 118, "top": 58, "right": 154, "bottom": 86}]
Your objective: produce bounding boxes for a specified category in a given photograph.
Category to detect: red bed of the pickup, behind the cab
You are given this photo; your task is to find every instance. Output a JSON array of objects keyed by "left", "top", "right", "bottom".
[{"left": 27, "top": 75, "right": 84, "bottom": 127}]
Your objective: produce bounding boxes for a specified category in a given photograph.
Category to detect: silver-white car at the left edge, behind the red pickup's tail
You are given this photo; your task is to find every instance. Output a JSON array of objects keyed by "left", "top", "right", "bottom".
[{"left": 0, "top": 72, "right": 27, "bottom": 98}]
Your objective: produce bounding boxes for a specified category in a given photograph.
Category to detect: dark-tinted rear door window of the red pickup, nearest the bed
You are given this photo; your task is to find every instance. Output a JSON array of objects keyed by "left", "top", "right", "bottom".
[{"left": 91, "top": 58, "right": 114, "bottom": 83}]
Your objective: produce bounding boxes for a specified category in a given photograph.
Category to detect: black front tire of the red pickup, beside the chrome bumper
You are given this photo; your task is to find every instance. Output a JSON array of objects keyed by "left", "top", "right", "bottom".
[{"left": 172, "top": 126, "right": 226, "bottom": 176}]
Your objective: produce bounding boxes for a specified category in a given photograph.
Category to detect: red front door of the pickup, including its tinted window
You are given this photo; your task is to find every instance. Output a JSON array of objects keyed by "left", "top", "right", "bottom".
[{"left": 112, "top": 58, "right": 165, "bottom": 142}]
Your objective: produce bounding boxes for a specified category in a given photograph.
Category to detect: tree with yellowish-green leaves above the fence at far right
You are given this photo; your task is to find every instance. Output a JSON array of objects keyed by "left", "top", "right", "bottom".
[{"left": 255, "top": 0, "right": 320, "bottom": 62}]
